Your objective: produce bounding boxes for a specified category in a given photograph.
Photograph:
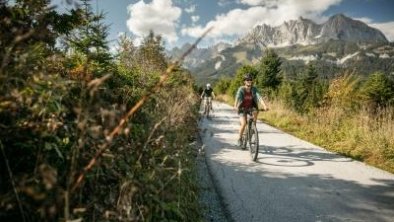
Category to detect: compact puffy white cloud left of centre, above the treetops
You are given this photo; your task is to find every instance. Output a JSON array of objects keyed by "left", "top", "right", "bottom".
[{"left": 127, "top": 0, "right": 182, "bottom": 43}]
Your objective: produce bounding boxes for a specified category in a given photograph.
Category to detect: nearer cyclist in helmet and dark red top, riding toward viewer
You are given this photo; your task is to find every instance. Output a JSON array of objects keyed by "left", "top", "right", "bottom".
[{"left": 234, "top": 73, "right": 268, "bottom": 146}]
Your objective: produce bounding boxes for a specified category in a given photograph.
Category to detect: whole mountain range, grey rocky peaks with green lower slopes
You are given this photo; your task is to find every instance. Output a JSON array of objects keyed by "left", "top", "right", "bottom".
[{"left": 169, "top": 14, "right": 394, "bottom": 84}]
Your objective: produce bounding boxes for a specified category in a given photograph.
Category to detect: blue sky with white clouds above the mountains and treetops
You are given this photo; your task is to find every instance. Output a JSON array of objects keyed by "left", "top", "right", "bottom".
[{"left": 52, "top": 0, "right": 394, "bottom": 49}]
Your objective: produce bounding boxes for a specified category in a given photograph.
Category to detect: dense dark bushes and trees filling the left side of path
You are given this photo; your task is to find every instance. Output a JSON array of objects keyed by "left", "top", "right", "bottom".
[{"left": 0, "top": 0, "right": 200, "bottom": 221}]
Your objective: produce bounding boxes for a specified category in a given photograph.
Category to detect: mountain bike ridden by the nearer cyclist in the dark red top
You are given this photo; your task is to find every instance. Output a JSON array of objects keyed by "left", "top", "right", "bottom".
[{"left": 241, "top": 109, "right": 259, "bottom": 161}]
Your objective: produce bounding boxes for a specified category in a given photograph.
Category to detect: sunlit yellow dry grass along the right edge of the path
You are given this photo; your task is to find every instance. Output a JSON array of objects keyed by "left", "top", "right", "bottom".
[{"left": 260, "top": 101, "right": 394, "bottom": 172}]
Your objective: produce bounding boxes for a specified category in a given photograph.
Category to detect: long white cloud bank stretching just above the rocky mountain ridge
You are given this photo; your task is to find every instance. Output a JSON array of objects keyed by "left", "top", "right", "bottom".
[{"left": 182, "top": 0, "right": 342, "bottom": 38}]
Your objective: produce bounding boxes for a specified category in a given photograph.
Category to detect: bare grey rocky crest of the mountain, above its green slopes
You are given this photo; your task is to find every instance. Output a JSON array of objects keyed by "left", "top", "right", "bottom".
[{"left": 239, "top": 14, "right": 388, "bottom": 47}]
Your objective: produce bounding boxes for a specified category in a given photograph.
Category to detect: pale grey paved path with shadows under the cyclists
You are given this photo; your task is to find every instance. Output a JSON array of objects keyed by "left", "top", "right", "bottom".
[{"left": 200, "top": 102, "right": 394, "bottom": 222}]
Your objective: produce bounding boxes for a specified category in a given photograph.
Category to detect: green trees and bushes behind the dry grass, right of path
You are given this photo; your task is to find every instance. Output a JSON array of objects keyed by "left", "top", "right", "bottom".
[{"left": 215, "top": 49, "right": 394, "bottom": 114}]
